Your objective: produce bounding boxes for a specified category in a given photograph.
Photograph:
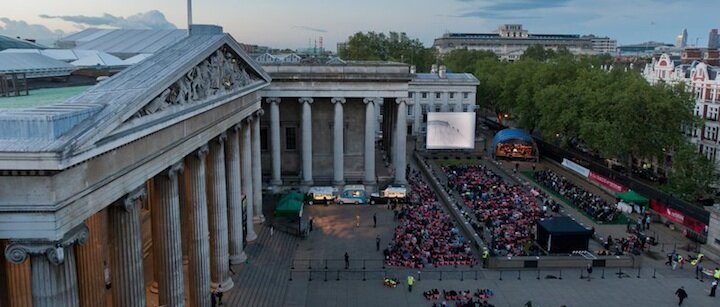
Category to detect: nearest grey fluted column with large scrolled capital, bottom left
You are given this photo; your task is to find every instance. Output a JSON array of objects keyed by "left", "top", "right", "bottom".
[{"left": 5, "top": 224, "right": 88, "bottom": 307}]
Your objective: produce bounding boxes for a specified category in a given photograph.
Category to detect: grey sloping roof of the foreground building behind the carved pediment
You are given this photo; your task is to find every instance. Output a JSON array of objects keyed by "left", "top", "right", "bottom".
[{"left": 0, "top": 25, "right": 270, "bottom": 157}]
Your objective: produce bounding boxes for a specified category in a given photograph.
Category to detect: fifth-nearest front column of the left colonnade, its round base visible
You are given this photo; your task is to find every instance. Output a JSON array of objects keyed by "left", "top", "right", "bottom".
[{"left": 207, "top": 133, "right": 233, "bottom": 290}]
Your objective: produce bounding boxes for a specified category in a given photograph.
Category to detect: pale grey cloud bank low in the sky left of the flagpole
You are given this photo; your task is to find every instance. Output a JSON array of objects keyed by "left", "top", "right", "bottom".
[{"left": 40, "top": 10, "right": 177, "bottom": 29}]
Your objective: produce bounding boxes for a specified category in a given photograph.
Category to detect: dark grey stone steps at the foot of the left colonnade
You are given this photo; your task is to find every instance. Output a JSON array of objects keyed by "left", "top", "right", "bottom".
[{"left": 223, "top": 225, "right": 299, "bottom": 307}]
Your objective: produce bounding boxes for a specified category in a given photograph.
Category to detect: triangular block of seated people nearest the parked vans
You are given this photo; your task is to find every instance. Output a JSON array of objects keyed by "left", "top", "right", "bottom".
[{"left": 383, "top": 170, "right": 476, "bottom": 268}]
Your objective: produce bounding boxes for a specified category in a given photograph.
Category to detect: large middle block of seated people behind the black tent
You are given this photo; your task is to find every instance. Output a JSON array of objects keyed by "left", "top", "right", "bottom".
[{"left": 444, "top": 165, "right": 548, "bottom": 256}]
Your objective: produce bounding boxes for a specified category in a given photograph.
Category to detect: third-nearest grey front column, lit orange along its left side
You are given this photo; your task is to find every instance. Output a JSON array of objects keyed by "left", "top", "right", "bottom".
[{"left": 150, "top": 162, "right": 185, "bottom": 306}]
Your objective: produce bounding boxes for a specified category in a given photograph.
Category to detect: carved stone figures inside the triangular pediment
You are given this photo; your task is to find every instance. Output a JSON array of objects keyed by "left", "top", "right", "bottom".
[{"left": 133, "top": 46, "right": 260, "bottom": 118}]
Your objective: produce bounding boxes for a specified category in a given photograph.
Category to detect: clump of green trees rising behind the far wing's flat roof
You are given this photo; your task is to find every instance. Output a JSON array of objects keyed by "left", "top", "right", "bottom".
[{"left": 339, "top": 31, "right": 435, "bottom": 71}]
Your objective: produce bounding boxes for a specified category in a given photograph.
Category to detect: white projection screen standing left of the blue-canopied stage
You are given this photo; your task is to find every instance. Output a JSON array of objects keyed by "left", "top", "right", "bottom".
[{"left": 425, "top": 112, "right": 475, "bottom": 149}]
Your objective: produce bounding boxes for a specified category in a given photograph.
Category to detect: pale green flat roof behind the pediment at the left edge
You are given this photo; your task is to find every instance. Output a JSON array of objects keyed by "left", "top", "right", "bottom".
[{"left": 0, "top": 85, "right": 92, "bottom": 109}]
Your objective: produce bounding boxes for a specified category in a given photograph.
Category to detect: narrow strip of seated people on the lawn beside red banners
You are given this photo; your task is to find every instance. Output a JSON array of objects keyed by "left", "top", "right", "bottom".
[{"left": 535, "top": 170, "right": 620, "bottom": 223}]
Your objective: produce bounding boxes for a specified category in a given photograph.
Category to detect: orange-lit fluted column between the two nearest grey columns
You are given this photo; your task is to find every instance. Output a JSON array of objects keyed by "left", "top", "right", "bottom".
[{"left": 76, "top": 209, "right": 107, "bottom": 307}]
